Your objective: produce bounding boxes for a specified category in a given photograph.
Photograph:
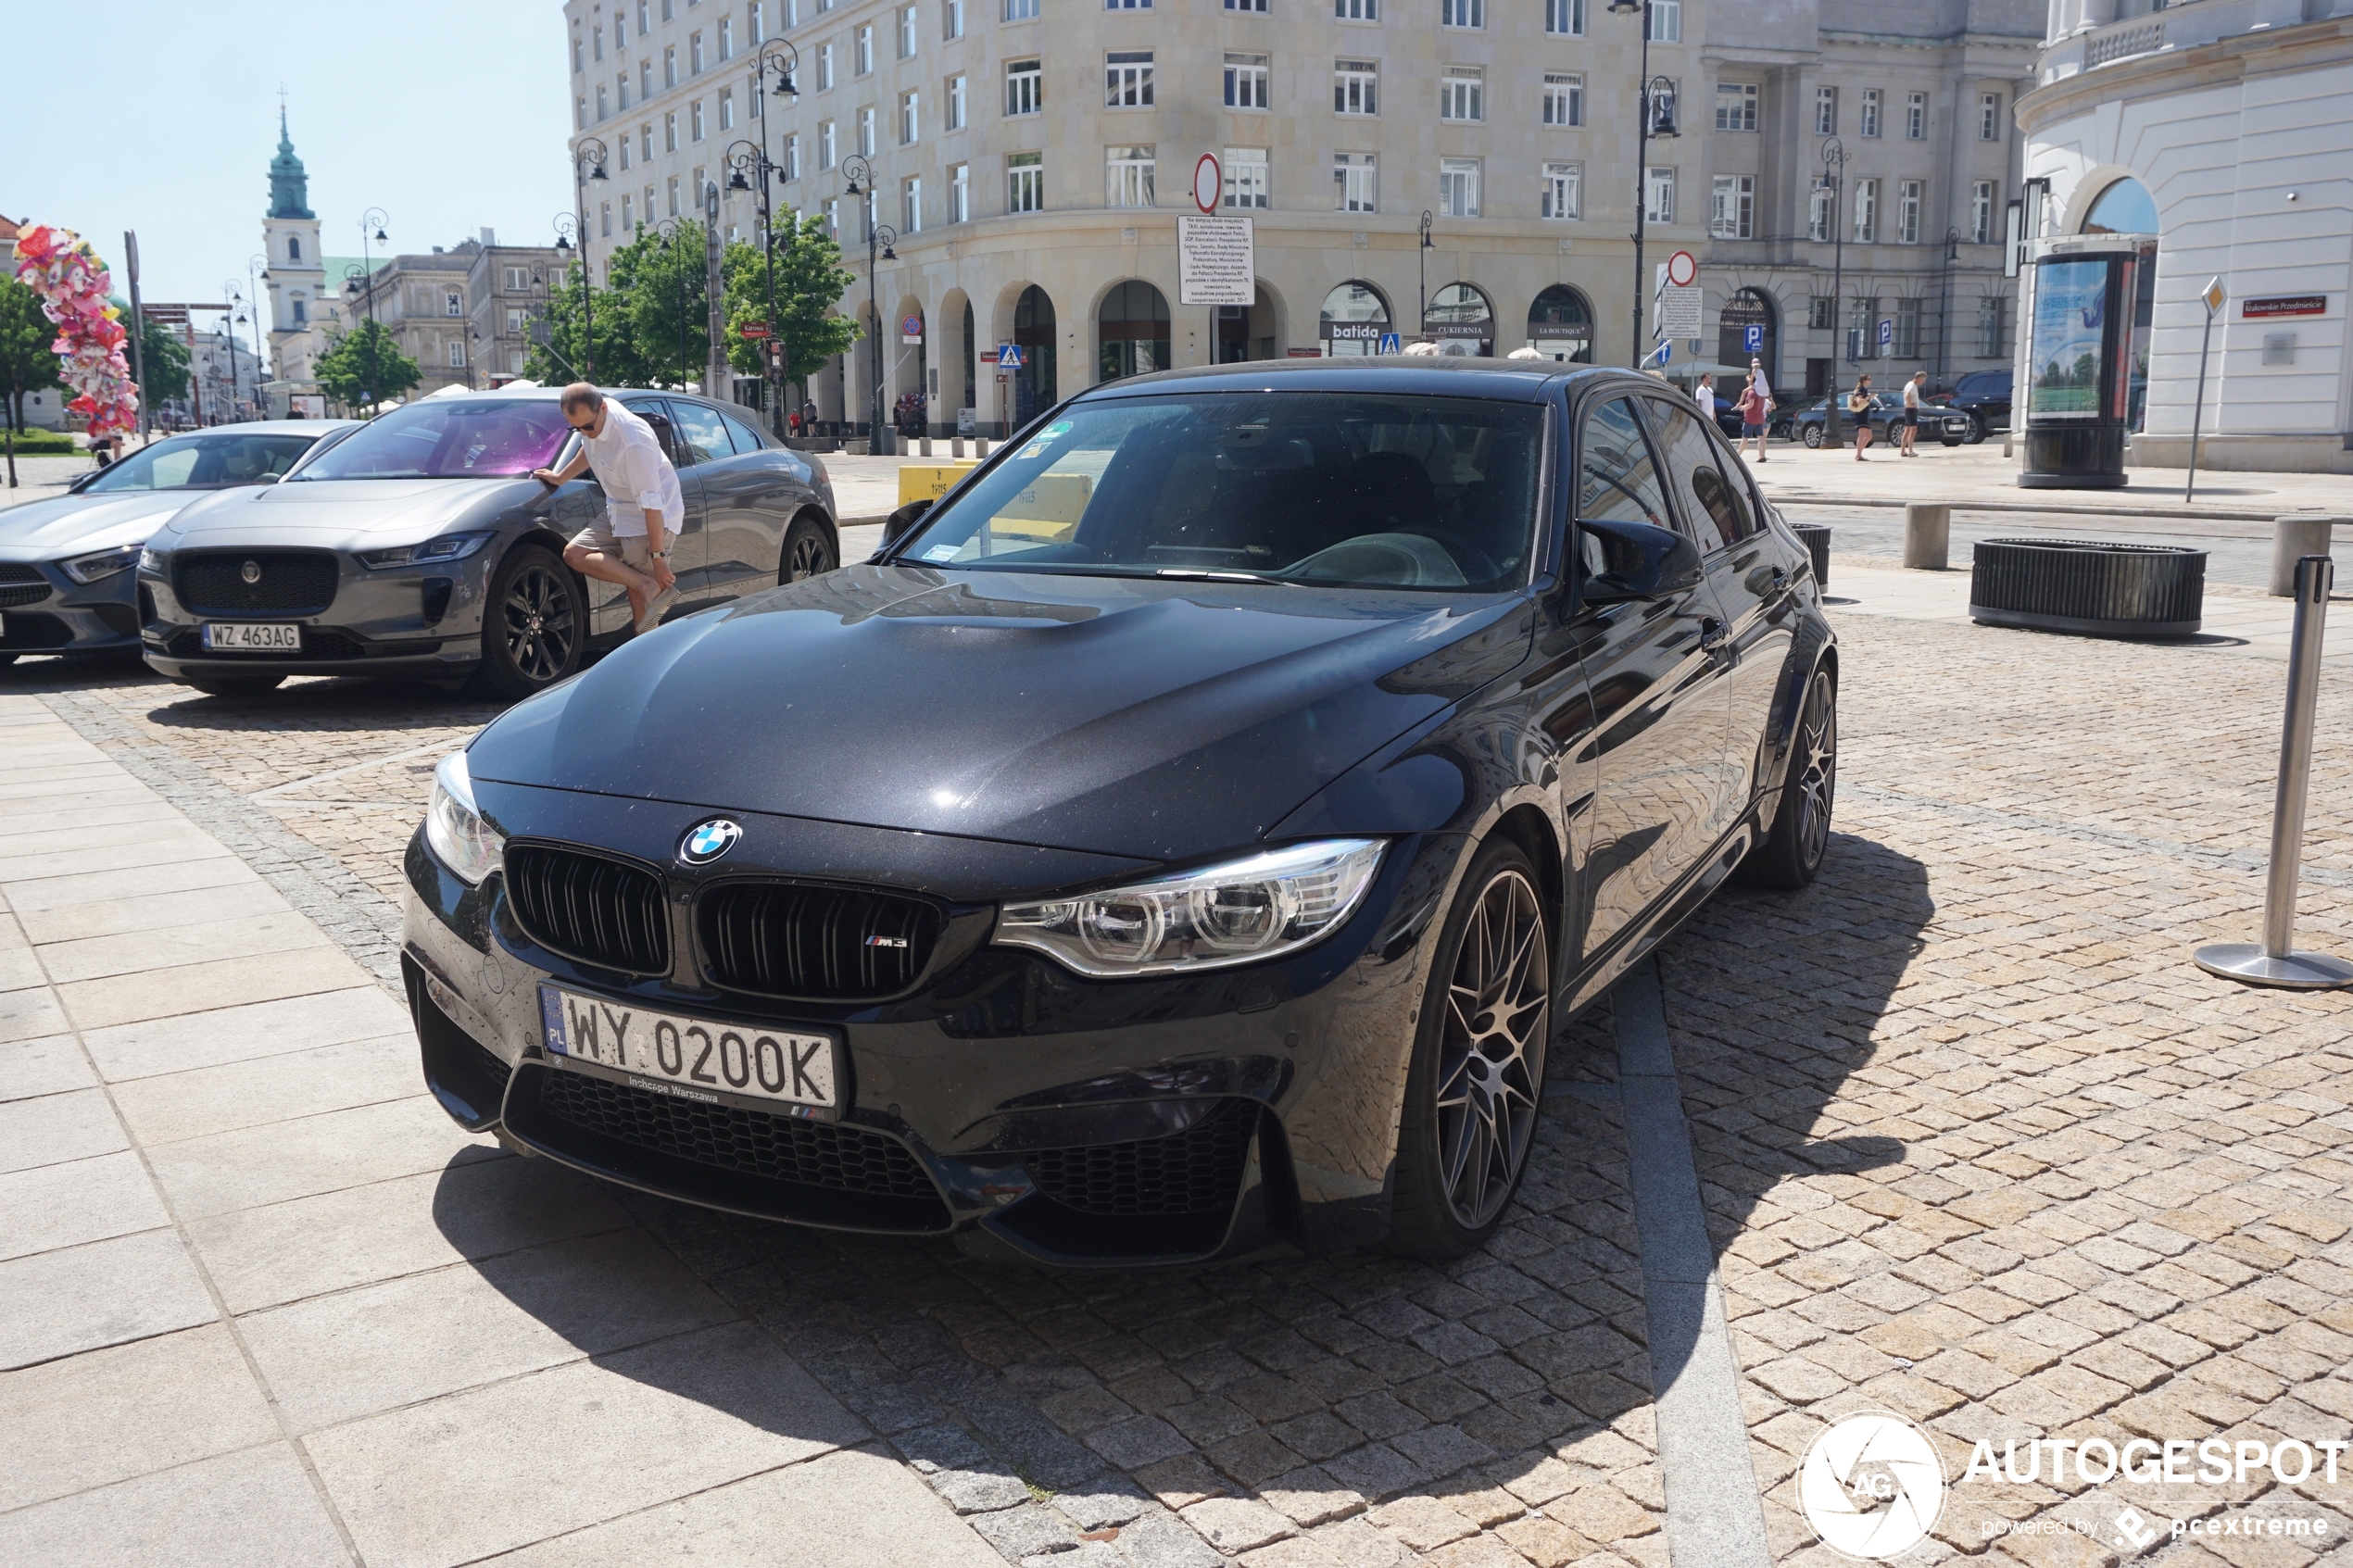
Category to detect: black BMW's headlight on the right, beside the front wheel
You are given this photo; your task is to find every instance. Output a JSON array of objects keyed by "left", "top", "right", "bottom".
[{"left": 993, "top": 839, "right": 1386, "bottom": 980}]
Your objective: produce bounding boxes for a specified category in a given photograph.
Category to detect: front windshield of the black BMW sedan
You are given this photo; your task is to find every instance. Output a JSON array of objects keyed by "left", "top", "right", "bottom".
[{"left": 897, "top": 393, "right": 1543, "bottom": 593}]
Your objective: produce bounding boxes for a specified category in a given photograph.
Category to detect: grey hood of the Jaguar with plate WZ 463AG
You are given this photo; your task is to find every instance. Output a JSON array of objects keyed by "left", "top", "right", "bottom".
[{"left": 167, "top": 477, "right": 555, "bottom": 550}]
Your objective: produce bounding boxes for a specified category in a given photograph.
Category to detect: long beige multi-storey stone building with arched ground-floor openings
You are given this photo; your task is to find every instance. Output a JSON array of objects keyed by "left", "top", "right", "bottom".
[{"left": 565, "top": 0, "right": 2043, "bottom": 430}]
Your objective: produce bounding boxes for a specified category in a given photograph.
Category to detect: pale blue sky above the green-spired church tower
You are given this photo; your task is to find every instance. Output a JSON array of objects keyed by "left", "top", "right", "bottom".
[{"left": 0, "top": 0, "right": 572, "bottom": 303}]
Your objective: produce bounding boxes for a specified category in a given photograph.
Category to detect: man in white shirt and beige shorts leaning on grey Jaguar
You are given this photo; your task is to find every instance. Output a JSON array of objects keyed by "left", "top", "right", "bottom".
[{"left": 532, "top": 381, "right": 687, "bottom": 633}]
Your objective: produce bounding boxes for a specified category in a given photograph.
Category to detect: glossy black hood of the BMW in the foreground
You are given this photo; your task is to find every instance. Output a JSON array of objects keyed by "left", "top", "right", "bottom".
[{"left": 468, "top": 567, "right": 1532, "bottom": 860}]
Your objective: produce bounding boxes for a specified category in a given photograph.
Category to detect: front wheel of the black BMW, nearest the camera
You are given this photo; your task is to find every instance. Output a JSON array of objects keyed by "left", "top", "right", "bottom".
[{"left": 1389, "top": 837, "right": 1553, "bottom": 1260}]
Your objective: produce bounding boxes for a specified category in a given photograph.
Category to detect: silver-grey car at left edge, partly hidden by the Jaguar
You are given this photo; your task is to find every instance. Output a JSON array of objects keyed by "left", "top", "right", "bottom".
[{"left": 0, "top": 419, "right": 360, "bottom": 665}]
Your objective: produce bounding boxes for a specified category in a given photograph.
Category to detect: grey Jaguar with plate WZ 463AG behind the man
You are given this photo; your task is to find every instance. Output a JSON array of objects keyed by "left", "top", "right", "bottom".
[{"left": 139, "top": 388, "right": 842, "bottom": 698}]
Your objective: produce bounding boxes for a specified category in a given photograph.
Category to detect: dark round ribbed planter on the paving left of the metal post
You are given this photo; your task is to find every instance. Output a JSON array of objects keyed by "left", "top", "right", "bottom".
[{"left": 1969, "top": 538, "right": 2208, "bottom": 637}]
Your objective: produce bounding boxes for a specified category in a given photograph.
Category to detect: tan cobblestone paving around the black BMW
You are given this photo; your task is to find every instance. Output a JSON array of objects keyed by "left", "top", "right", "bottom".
[{"left": 0, "top": 583, "right": 2353, "bottom": 1568}]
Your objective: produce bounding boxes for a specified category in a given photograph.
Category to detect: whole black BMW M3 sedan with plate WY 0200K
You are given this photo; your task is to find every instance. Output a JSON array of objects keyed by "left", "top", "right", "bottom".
[{"left": 402, "top": 359, "right": 1838, "bottom": 1267}]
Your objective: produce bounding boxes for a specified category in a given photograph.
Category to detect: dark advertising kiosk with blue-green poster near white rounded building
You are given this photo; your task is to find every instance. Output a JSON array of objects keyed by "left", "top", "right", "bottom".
[{"left": 2019, "top": 235, "right": 2158, "bottom": 489}]
